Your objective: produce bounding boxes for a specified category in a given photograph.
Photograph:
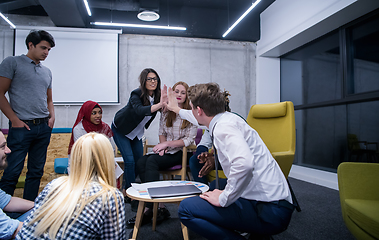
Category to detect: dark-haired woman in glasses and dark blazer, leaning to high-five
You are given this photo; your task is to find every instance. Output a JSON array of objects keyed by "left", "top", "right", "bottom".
[{"left": 111, "top": 68, "right": 167, "bottom": 205}]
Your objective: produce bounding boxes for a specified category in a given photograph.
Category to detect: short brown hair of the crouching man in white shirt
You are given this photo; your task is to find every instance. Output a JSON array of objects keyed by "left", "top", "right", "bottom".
[{"left": 188, "top": 83, "right": 229, "bottom": 117}]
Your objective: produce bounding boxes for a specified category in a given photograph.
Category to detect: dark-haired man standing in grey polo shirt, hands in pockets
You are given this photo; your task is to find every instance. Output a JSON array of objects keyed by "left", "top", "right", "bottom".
[{"left": 0, "top": 30, "right": 55, "bottom": 201}]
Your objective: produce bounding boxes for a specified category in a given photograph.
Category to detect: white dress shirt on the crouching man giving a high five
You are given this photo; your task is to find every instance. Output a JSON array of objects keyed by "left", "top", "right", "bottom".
[{"left": 209, "top": 112, "right": 292, "bottom": 207}]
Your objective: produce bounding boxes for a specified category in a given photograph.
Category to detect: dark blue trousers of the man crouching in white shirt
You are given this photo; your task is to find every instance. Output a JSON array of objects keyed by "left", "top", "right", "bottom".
[{"left": 178, "top": 179, "right": 294, "bottom": 240}]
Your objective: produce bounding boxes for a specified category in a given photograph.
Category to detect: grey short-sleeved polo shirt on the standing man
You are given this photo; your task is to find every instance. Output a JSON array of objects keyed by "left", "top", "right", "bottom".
[{"left": 0, "top": 55, "right": 52, "bottom": 120}]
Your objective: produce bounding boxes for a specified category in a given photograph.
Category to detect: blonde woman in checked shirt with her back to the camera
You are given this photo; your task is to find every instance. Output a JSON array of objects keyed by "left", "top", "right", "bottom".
[{"left": 16, "top": 132, "right": 126, "bottom": 239}]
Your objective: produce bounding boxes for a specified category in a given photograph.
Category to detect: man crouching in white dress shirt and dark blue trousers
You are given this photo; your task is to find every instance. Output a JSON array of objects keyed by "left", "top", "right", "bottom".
[{"left": 179, "top": 83, "right": 294, "bottom": 240}]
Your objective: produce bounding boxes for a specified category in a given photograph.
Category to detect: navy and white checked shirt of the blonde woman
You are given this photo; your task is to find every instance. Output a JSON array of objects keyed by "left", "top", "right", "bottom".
[{"left": 16, "top": 180, "right": 126, "bottom": 240}]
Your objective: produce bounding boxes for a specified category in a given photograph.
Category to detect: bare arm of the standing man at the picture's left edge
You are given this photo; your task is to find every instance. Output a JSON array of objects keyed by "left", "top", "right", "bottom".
[{"left": 0, "top": 77, "right": 30, "bottom": 130}]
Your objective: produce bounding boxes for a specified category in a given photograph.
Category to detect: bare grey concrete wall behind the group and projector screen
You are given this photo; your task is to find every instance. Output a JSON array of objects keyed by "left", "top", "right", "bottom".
[{"left": 0, "top": 15, "right": 256, "bottom": 143}]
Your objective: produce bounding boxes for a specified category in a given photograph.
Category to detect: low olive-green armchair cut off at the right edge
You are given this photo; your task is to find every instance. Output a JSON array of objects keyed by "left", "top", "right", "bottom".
[{"left": 337, "top": 162, "right": 379, "bottom": 240}]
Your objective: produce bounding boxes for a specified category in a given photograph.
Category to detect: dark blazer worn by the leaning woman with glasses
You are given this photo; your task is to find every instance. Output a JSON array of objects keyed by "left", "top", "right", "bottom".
[{"left": 113, "top": 88, "right": 157, "bottom": 135}]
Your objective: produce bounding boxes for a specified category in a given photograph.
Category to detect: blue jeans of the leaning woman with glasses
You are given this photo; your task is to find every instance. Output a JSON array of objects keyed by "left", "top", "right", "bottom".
[{"left": 111, "top": 124, "right": 143, "bottom": 189}]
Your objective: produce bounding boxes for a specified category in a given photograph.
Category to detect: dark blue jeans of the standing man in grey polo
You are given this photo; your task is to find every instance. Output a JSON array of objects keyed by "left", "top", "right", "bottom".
[{"left": 0, "top": 122, "right": 52, "bottom": 201}]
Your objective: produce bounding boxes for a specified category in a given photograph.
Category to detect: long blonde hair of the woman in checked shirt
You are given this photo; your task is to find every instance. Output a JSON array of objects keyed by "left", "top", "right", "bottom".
[{"left": 29, "top": 132, "right": 122, "bottom": 239}]
